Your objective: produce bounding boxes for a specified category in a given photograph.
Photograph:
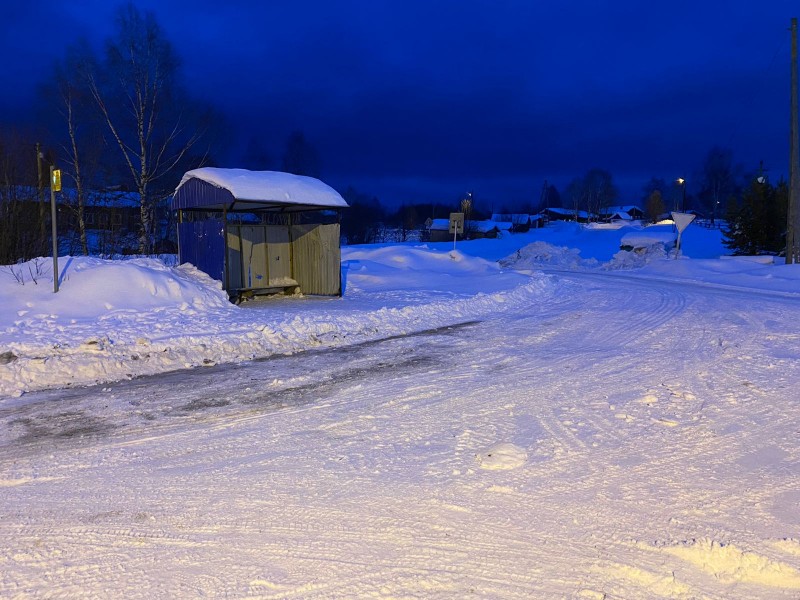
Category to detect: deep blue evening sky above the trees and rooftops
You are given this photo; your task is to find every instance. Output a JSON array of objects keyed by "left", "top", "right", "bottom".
[{"left": 0, "top": 0, "right": 800, "bottom": 206}]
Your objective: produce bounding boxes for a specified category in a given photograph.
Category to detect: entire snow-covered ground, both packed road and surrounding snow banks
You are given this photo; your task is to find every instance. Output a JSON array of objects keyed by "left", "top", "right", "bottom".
[{"left": 0, "top": 224, "right": 800, "bottom": 599}]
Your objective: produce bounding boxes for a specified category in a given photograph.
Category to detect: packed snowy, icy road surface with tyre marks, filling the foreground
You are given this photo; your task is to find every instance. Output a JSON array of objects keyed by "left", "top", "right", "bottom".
[{"left": 0, "top": 273, "right": 800, "bottom": 599}]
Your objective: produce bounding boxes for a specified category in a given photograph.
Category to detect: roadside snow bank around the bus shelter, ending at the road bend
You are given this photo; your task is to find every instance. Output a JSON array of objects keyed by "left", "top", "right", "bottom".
[{"left": 0, "top": 247, "right": 553, "bottom": 396}]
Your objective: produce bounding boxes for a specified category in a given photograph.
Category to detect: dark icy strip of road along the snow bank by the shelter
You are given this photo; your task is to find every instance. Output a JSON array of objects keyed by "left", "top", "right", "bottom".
[{"left": 0, "top": 322, "right": 475, "bottom": 459}]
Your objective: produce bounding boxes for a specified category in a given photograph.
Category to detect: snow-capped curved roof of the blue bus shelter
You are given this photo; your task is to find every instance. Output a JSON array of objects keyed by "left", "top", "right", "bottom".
[{"left": 172, "top": 167, "right": 347, "bottom": 211}]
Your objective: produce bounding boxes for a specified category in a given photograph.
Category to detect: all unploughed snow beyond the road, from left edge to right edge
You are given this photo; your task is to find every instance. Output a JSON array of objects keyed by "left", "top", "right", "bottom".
[{"left": 0, "top": 223, "right": 800, "bottom": 396}]
